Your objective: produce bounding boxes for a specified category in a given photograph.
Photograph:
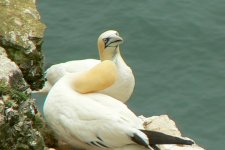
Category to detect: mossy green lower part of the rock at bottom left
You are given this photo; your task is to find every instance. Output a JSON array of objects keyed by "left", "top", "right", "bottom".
[{"left": 0, "top": 80, "right": 45, "bottom": 150}]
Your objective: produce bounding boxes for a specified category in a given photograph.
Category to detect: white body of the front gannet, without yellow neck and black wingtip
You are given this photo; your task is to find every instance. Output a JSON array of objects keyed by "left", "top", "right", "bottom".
[{"left": 44, "top": 74, "right": 143, "bottom": 149}]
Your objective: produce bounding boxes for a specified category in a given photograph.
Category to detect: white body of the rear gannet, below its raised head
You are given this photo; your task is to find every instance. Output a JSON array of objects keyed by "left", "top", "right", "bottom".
[{"left": 43, "top": 55, "right": 135, "bottom": 103}]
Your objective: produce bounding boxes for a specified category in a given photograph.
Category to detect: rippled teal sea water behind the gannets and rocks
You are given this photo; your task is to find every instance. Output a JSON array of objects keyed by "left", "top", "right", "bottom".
[{"left": 37, "top": 0, "right": 225, "bottom": 150}]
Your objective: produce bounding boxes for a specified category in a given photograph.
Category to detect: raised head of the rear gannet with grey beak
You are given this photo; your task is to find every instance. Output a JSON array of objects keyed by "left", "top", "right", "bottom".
[{"left": 98, "top": 30, "right": 123, "bottom": 61}]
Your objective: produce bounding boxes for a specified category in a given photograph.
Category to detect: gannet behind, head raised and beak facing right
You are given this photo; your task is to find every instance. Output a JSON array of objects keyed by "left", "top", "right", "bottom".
[{"left": 33, "top": 30, "right": 135, "bottom": 103}]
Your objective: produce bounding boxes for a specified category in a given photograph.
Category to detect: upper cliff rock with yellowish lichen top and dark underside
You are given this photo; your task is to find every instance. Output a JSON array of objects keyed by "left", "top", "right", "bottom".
[{"left": 0, "top": 0, "right": 45, "bottom": 89}]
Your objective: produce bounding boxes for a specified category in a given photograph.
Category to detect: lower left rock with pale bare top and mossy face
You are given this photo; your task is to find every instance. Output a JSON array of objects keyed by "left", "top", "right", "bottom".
[{"left": 0, "top": 47, "right": 45, "bottom": 150}]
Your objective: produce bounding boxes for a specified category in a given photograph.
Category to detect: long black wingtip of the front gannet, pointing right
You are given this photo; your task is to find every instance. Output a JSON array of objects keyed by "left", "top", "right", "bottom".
[{"left": 141, "top": 130, "right": 194, "bottom": 145}]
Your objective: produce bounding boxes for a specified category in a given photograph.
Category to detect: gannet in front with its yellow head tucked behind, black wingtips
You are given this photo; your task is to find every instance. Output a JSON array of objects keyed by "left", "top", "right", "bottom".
[{"left": 43, "top": 60, "right": 193, "bottom": 150}]
